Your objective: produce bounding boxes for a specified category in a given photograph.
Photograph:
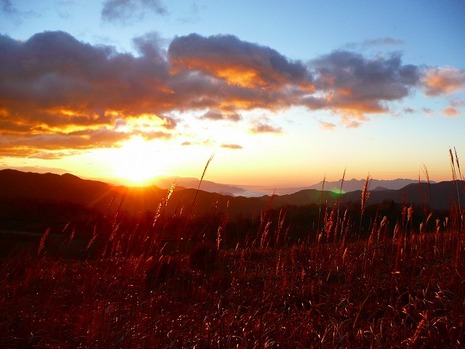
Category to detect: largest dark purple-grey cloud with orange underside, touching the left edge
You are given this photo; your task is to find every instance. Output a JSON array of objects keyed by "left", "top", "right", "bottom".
[{"left": 0, "top": 32, "right": 173, "bottom": 133}]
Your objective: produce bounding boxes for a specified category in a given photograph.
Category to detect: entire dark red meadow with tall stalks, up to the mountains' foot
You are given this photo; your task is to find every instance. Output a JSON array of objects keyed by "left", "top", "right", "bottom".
[{"left": 0, "top": 162, "right": 465, "bottom": 348}]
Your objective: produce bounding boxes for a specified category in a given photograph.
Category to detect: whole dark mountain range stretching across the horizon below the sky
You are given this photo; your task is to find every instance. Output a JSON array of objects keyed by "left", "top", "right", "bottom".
[{"left": 0, "top": 169, "right": 465, "bottom": 218}]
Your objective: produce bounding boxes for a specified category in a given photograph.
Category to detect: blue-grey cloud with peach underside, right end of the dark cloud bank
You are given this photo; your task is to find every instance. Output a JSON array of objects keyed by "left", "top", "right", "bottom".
[{"left": 308, "top": 51, "right": 421, "bottom": 115}]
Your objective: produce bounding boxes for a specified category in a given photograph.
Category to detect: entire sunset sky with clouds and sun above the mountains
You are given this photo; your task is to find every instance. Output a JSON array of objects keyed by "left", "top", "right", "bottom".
[{"left": 0, "top": 0, "right": 465, "bottom": 187}]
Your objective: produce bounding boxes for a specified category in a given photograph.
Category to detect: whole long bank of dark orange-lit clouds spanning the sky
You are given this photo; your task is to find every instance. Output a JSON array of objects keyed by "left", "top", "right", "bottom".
[{"left": 0, "top": 31, "right": 465, "bottom": 156}]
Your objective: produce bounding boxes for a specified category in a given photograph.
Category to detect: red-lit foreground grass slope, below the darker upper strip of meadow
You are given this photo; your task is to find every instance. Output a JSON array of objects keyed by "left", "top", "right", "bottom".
[{"left": 0, "top": 228, "right": 465, "bottom": 348}]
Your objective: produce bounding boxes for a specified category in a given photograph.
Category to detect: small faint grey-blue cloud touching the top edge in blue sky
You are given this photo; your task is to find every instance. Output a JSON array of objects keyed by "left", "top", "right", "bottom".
[{"left": 101, "top": 0, "right": 167, "bottom": 22}]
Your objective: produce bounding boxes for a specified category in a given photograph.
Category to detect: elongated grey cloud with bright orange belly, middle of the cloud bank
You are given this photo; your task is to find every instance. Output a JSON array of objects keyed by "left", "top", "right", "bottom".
[{"left": 168, "top": 34, "right": 313, "bottom": 89}]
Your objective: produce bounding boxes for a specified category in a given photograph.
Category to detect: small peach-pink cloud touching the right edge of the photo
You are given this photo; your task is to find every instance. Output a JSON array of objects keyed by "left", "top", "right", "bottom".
[{"left": 422, "top": 67, "right": 465, "bottom": 96}]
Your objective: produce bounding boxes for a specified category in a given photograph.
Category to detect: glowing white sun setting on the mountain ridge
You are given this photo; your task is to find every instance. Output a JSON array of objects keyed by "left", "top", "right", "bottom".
[{"left": 111, "top": 137, "right": 164, "bottom": 185}]
